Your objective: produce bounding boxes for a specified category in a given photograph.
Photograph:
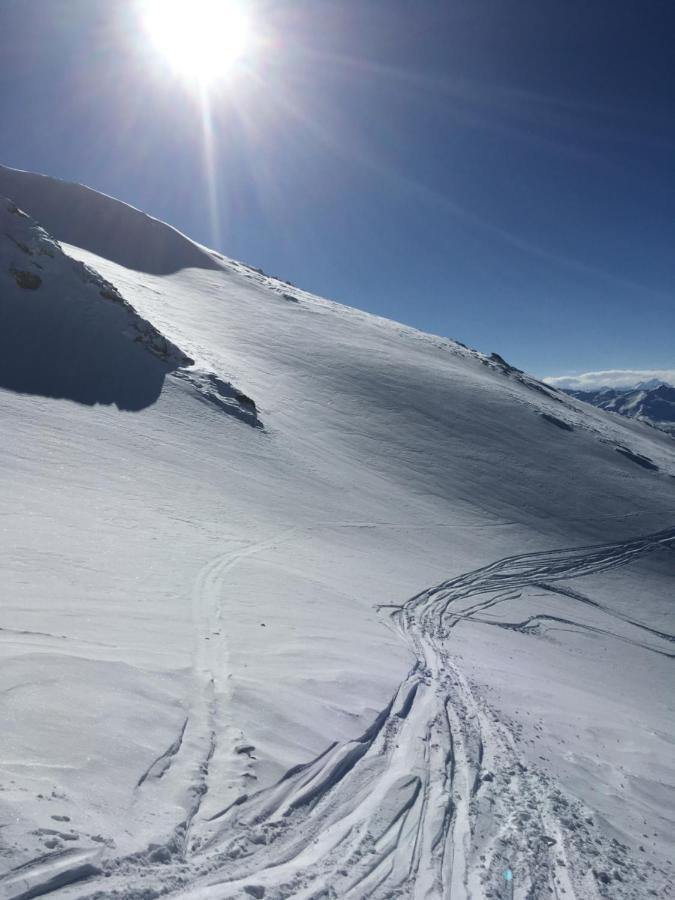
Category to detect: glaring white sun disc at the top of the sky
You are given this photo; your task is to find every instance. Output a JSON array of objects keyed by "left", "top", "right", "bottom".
[{"left": 141, "top": 0, "right": 251, "bottom": 86}]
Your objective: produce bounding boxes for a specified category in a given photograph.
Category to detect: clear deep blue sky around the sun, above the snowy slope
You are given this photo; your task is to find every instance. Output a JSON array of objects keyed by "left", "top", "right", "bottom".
[{"left": 0, "top": 0, "right": 675, "bottom": 376}]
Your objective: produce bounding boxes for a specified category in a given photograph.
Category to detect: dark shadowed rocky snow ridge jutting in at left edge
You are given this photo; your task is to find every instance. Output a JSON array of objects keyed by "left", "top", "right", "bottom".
[{"left": 0, "top": 198, "right": 259, "bottom": 424}]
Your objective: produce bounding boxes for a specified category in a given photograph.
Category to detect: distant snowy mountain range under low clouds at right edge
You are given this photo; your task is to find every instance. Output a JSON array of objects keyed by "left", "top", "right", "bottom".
[{"left": 565, "top": 379, "right": 675, "bottom": 437}]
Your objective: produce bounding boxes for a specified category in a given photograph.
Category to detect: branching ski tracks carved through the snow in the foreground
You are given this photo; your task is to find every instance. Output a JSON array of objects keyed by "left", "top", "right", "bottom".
[{"left": 5, "top": 528, "right": 675, "bottom": 900}]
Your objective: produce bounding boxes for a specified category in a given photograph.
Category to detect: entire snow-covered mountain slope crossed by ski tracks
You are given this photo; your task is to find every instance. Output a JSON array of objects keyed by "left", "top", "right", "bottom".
[{"left": 0, "top": 168, "right": 675, "bottom": 900}]
